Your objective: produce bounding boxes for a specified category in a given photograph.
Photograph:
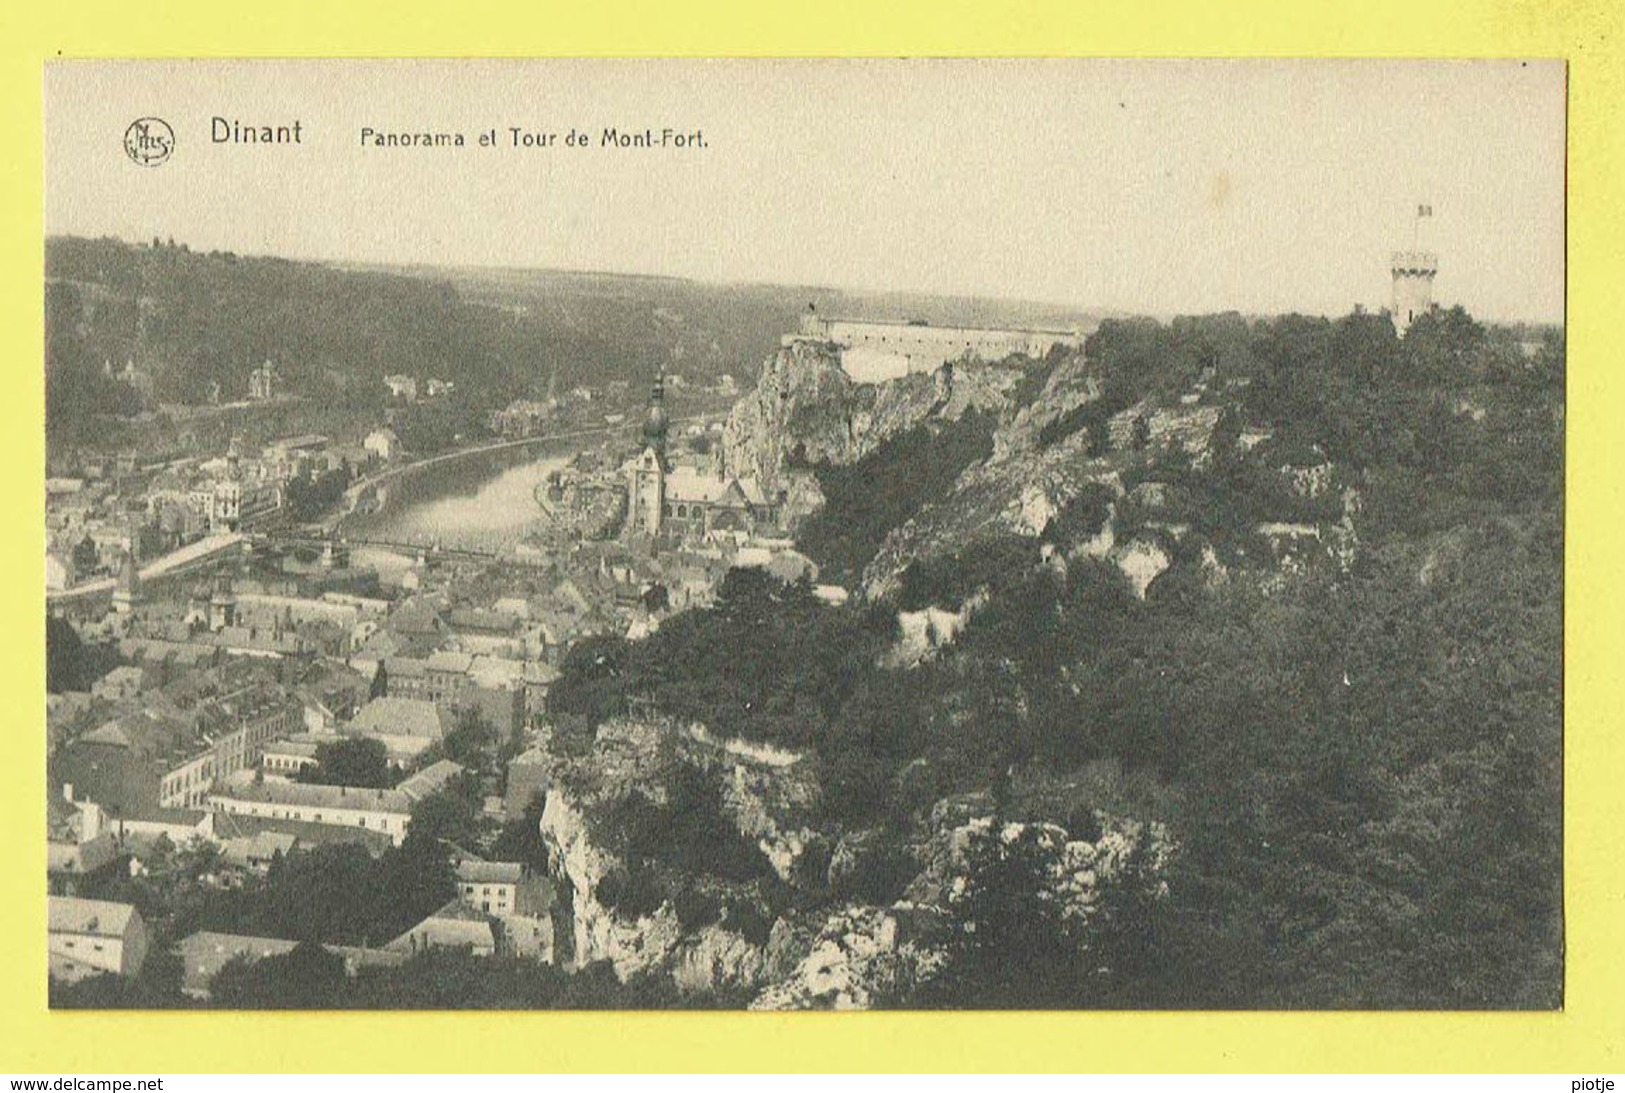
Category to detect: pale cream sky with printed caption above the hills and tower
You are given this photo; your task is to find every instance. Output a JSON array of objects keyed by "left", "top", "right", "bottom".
[{"left": 46, "top": 60, "right": 1565, "bottom": 322}]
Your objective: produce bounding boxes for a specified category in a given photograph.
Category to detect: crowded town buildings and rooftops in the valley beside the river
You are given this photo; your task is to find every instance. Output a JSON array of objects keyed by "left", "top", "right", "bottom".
[{"left": 47, "top": 355, "right": 777, "bottom": 997}]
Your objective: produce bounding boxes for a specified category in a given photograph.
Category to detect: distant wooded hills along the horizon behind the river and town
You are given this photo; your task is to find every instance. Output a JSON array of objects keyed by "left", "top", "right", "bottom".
[{"left": 46, "top": 237, "right": 1099, "bottom": 435}]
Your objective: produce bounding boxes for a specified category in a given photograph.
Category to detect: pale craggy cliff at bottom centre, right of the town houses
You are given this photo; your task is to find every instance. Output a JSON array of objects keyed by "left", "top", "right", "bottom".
[{"left": 541, "top": 721, "right": 1172, "bottom": 1010}]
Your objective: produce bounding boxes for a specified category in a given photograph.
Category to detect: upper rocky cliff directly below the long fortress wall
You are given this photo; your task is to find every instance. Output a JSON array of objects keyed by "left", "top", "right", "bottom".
[{"left": 725, "top": 343, "right": 1352, "bottom": 601}]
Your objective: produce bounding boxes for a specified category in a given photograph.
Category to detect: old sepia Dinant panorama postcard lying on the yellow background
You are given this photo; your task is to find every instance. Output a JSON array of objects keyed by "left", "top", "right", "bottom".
[{"left": 41, "top": 58, "right": 1567, "bottom": 1010}]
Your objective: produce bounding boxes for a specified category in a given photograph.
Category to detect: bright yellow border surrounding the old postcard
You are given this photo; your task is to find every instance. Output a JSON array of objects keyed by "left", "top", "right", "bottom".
[{"left": 0, "top": 0, "right": 1625, "bottom": 1075}]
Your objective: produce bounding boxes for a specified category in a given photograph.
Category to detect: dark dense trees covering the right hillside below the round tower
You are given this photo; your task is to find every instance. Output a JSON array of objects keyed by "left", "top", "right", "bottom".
[{"left": 561, "top": 302, "right": 1563, "bottom": 1009}]
